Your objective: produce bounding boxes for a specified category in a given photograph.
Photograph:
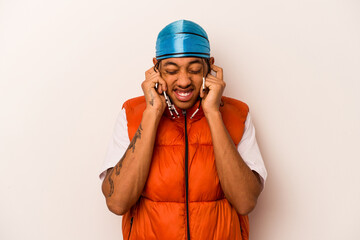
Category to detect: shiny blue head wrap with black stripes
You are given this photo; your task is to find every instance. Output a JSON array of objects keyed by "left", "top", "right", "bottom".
[{"left": 156, "top": 20, "right": 210, "bottom": 60}]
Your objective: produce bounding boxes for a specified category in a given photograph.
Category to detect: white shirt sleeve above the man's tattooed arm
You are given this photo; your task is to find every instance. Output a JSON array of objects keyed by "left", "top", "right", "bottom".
[{"left": 99, "top": 109, "right": 130, "bottom": 180}]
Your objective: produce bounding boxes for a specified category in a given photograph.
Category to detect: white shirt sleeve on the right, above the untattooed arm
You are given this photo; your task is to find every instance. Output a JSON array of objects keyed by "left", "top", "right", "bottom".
[{"left": 237, "top": 113, "right": 267, "bottom": 186}]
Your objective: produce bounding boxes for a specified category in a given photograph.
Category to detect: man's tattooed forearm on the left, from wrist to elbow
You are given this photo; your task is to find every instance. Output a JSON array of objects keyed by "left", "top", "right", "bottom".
[{"left": 102, "top": 110, "right": 159, "bottom": 215}]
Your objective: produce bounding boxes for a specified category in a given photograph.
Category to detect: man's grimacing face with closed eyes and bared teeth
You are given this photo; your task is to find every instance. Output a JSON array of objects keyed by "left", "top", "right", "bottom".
[{"left": 154, "top": 57, "right": 213, "bottom": 109}]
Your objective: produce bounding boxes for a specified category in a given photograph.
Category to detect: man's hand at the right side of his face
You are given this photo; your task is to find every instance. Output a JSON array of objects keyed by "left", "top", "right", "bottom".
[{"left": 200, "top": 65, "right": 226, "bottom": 116}]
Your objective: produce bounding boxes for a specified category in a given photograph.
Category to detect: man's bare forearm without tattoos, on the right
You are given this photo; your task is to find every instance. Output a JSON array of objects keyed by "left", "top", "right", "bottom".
[{"left": 207, "top": 112, "right": 262, "bottom": 214}]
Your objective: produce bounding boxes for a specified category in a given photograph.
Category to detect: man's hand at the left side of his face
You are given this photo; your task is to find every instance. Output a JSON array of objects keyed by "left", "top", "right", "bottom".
[{"left": 141, "top": 67, "right": 167, "bottom": 117}]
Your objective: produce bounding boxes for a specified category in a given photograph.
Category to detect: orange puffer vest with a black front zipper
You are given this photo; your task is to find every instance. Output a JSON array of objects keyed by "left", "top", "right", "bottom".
[{"left": 122, "top": 97, "right": 249, "bottom": 240}]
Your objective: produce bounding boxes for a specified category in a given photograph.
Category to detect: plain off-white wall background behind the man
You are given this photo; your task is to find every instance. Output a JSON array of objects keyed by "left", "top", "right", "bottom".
[{"left": 0, "top": 0, "right": 360, "bottom": 240}]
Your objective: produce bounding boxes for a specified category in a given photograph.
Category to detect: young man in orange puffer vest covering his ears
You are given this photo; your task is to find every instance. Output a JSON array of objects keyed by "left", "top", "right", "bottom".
[{"left": 100, "top": 20, "right": 267, "bottom": 240}]
